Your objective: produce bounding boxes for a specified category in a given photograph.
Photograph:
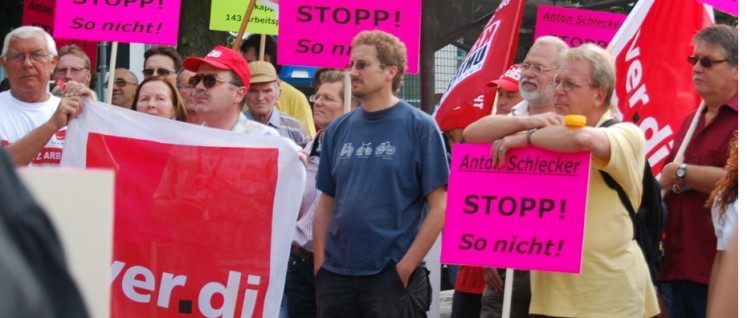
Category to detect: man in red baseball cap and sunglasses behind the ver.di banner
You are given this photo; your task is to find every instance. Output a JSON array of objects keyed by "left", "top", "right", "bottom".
[{"left": 183, "top": 45, "right": 278, "bottom": 136}]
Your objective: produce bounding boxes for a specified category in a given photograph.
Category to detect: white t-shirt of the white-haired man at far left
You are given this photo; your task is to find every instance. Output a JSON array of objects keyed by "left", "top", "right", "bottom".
[{"left": 0, "top": 91, "right": 67, "bottom": 167}]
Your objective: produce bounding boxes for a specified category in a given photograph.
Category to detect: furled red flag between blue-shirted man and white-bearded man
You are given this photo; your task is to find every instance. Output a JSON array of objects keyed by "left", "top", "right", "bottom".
[{"left": 433, "top": 0, "right": 524, "bottom": 131}]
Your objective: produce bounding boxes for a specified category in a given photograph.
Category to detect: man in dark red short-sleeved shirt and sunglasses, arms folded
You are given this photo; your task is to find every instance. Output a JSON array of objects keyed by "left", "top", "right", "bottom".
[{"left": 660, "top": 25, "right": 739, "bottom": 317}]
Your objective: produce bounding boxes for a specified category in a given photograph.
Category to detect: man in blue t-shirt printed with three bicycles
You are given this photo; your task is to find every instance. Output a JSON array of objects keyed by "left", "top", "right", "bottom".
[{"left": 313, "top": 31, "right": 448, "bottom": 317}]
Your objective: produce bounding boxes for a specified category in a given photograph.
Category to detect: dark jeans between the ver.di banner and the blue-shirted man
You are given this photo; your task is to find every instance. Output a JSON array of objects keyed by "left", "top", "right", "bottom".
[{"left": 281, "top": 249, "right": 316, "bottom": 318}]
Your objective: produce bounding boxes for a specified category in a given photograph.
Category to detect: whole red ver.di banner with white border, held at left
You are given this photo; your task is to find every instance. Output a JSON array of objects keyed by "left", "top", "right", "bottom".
[{"left": 61, "top": 101, "right": 305, "bottom": 317}]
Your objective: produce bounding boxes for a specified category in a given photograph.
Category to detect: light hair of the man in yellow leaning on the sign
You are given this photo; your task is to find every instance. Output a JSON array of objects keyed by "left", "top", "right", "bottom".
[{"left": 563, "top": 43, "right": 615, "bottom": 107}]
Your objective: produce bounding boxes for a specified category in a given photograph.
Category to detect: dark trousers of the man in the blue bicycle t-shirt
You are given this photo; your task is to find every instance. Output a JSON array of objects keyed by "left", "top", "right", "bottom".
[{"left": 316, "top": 264, "right": 432, "bottom": 318}]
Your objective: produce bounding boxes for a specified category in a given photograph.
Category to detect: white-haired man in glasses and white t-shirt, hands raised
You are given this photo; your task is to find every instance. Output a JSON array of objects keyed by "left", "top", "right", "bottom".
[{"left": 0, "top": 26, "right": 93, "bottom": 166}]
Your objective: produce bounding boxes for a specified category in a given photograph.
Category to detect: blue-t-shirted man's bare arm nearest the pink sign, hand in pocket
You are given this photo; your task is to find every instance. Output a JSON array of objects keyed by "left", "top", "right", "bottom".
[{"left": 394, "top": 186, "right": 446, "bottom": 287}]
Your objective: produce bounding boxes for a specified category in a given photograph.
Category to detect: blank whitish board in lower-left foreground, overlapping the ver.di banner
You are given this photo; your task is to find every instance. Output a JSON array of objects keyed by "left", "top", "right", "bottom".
[{"left": 18, "top": 168, "right": 114, "bottom": 317}]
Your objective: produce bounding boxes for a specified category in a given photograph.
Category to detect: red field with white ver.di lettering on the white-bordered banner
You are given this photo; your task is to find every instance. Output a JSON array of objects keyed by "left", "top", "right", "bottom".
[{"left": 86, "top": 134, "right": 278, "bottom": 317}]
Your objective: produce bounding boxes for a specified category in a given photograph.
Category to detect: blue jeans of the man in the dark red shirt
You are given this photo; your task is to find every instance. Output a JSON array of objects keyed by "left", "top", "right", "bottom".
[{"left": 667, "top": 280, "right": 708, "bottom": 318}]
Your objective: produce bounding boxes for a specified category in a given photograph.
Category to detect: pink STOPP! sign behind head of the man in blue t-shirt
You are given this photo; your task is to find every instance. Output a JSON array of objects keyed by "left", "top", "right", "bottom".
[{"left": 278, "top": 0, "right": 421, "bottom": 73}]
